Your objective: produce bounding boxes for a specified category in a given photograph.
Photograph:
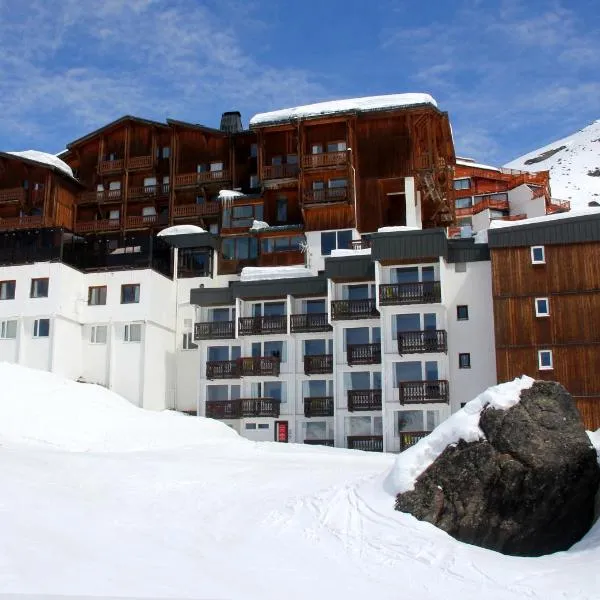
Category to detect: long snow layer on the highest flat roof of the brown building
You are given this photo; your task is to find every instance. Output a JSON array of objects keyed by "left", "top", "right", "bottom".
[{"left": 250, "top": 93, "right": 437, "bottom": 126}]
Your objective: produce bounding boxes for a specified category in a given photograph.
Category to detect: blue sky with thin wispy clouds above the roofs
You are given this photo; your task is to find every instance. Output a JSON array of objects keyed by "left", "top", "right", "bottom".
[{"left": 0, "top": 0, "right": 600, "bottom": 164}]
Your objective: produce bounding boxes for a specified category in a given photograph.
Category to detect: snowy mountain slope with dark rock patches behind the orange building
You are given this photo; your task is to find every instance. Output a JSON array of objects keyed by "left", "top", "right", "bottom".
[{"left": 504, "top": 120, "right": 600, "bottom": 209}]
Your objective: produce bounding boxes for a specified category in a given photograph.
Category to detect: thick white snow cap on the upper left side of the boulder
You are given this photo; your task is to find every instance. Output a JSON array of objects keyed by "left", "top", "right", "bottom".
[{"left": 385, "top": 375, "right": 535, "bottom": 494}]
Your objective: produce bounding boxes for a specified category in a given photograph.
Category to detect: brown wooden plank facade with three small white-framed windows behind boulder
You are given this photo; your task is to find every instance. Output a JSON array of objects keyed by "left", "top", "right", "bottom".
[{"left": 491, "top": 240, "right": 600, "bottom": 430}]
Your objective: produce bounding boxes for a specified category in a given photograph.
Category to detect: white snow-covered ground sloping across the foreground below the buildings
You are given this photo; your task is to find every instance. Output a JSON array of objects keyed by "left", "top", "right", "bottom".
[{"left": 0, "top": 364, "right": 600, "bottom": 600}]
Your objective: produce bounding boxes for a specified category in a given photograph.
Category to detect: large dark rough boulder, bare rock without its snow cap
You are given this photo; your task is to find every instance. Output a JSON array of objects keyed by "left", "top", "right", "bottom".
[{"left": 396, "top": 381, "right": 600, "bottom": 556}]
